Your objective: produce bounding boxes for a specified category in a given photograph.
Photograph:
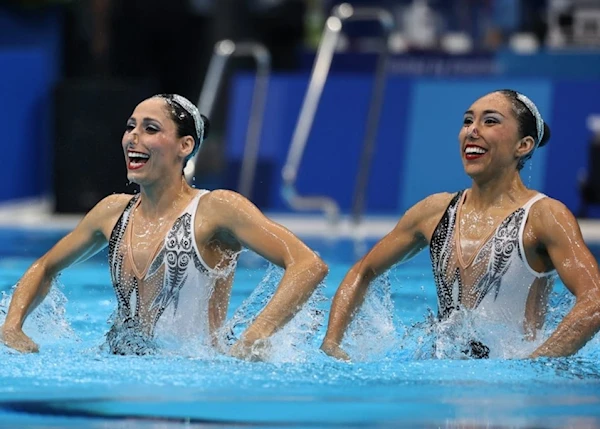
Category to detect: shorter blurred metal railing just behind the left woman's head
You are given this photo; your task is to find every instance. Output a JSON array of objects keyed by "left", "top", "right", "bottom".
[{"left": 184, "top": 40, "right": 271, "bottom": 197}]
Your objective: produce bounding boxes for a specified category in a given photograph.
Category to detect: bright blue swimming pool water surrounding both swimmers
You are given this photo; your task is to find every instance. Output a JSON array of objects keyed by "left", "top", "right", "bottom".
[{"left": 0, "top": 226, "right": 600, "bottom": 428}]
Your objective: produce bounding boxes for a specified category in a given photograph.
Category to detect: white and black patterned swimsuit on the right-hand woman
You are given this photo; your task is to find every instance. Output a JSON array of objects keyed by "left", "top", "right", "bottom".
[{"left": 430, "top": 191, "right": 555, "bottom": 358}]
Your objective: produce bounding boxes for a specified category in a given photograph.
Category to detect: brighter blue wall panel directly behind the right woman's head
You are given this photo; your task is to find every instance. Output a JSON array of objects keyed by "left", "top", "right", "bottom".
[{"left": 398, "top": 78, "right": 551, "bottom": 211}]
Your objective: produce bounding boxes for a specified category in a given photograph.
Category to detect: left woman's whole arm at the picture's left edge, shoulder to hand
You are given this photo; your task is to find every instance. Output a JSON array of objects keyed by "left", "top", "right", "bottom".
[{"left": 0, "top": 195, "right": 131, "bottom": 352}]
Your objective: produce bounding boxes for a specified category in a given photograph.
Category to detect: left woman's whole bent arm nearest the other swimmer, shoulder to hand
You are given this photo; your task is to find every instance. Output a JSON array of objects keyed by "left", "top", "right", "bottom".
[{"left": 201, "top": 190, "right": 328, "bottom": 357}]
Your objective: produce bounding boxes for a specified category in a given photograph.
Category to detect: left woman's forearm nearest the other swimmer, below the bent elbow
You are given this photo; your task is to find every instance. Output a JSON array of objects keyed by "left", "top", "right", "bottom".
[{"left": 244, "top": 260, "right": 328, "bottom": 342}]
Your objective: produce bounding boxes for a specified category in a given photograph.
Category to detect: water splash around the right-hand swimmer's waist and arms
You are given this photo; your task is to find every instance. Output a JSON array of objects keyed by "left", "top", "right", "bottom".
[{"left": 342, "top": 276, "right": 600, "bottom": 362}]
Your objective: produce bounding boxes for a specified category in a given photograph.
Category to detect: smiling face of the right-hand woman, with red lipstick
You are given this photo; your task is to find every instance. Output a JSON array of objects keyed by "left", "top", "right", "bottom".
[{"left": 458, "top": 92, "right": 531, "bottom": 179}]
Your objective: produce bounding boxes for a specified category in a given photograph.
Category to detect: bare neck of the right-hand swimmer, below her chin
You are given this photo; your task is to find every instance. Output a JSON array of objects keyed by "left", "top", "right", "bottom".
[{"left": 466, "top": 173, "right": 529, "bottom": 210}]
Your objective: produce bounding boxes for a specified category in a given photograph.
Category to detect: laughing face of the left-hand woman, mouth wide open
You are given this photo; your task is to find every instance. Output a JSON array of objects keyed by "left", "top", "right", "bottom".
[{"left": 122, "top": 98, "right": 193, "bottom": 185}]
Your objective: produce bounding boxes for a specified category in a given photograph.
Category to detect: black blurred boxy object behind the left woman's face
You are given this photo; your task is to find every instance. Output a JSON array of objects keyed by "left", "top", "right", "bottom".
[{"left": 54, "top": 80, "right": 152, "bottom": 213}]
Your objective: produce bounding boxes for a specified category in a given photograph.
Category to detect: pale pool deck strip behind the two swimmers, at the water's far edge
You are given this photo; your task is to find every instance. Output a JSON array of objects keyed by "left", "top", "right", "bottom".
[{"left": 0, "top": 198, "right": 600, "bottom": 244}]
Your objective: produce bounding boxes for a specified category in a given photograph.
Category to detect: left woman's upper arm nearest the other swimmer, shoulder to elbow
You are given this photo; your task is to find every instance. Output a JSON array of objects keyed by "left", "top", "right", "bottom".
[{"left": 203, "top": 190, "right": 320, "bottom": 267}]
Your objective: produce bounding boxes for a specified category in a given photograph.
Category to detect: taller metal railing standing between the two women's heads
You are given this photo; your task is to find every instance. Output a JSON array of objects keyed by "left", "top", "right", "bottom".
[{"left": 282, "top": 3, "right": 394, "bottom": 223}]
